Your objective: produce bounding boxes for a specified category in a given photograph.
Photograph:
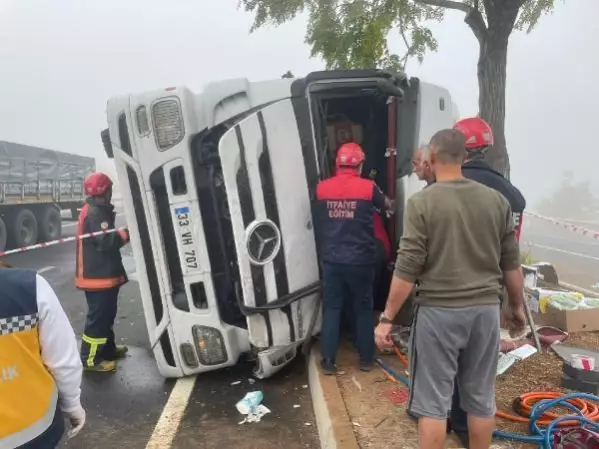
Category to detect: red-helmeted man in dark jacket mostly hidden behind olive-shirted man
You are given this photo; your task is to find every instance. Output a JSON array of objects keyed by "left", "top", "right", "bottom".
[{"left": 449, "top": 117, "right": 526, "bottom": 447}]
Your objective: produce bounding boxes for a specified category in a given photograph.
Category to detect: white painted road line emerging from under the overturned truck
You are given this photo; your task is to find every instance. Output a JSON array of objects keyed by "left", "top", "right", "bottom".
[{"left": 146, "top": 376, "right": 196, "bottom": 449}]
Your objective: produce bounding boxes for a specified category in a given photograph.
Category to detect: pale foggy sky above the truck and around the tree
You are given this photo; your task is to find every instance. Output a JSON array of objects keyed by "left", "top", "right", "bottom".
[{"left": 0, "top": 0, "right": 599, "bottom": 203}]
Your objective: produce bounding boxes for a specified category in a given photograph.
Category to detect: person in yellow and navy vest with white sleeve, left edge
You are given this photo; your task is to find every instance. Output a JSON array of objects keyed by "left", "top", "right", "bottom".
[{"left": 0, "top": 262, "right": 85, "bottom": 449}]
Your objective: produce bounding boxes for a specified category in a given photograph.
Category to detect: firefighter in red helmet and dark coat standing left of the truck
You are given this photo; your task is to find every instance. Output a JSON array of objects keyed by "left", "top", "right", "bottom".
[{"left": 75, "top": 173, "right": 129, "bottom": 372}]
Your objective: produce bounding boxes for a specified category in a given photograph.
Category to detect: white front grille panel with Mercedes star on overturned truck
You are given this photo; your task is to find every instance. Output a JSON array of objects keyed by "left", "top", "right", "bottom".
[{"left": 214, "top": 100, "right": 320, "bottom": 350}]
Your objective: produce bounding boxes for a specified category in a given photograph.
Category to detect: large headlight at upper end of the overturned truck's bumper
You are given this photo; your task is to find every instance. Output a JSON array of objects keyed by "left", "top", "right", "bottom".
[{"left": 152, "top": 98, "right": 185, "bottom": 151}]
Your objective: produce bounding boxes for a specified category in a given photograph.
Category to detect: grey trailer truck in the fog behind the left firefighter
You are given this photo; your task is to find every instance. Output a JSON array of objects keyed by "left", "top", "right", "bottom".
[{"left": 0, "top": 141, "right": 95, "bottom": 251}]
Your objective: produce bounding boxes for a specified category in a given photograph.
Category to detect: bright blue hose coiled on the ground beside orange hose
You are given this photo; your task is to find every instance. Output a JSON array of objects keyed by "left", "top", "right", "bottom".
[{"left": 376, "top": 359, "right": 599, "bottom": 449}]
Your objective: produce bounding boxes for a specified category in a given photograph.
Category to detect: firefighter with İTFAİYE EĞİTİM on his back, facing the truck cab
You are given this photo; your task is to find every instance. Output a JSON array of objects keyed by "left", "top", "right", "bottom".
[{"left": 315, "top": 143, "right": 393, "bottom": 375}]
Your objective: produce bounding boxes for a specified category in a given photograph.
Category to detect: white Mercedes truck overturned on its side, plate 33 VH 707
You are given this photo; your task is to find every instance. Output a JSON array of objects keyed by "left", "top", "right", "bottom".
[{"left": 102, "top": 70, "right": 457, "bottom": 377}]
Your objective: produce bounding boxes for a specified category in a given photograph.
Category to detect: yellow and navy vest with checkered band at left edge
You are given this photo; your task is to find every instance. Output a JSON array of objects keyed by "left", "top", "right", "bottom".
[{"left": 0, "top": 268, "right": 58, "bottom": 449}]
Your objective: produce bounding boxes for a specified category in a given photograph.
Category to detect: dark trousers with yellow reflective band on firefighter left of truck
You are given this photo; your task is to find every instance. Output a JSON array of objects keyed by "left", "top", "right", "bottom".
[{"left": 81, "top": 287, "right": 119, "bottom": 366}]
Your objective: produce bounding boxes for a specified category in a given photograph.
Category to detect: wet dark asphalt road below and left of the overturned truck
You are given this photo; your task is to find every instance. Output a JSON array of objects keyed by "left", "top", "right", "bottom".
[{"left": 6, "top": 209, "right": 319, "bottom": 449}]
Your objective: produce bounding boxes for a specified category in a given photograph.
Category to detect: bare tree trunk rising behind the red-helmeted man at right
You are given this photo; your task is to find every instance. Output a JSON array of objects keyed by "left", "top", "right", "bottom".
[{"left": 478, "top": 33, "right": 510, "bottom": 177}]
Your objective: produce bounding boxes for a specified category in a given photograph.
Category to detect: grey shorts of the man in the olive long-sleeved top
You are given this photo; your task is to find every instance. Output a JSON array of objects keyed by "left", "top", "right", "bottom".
[{"left": 408, "top": 305, "right": 500, "bottom": 419}]
